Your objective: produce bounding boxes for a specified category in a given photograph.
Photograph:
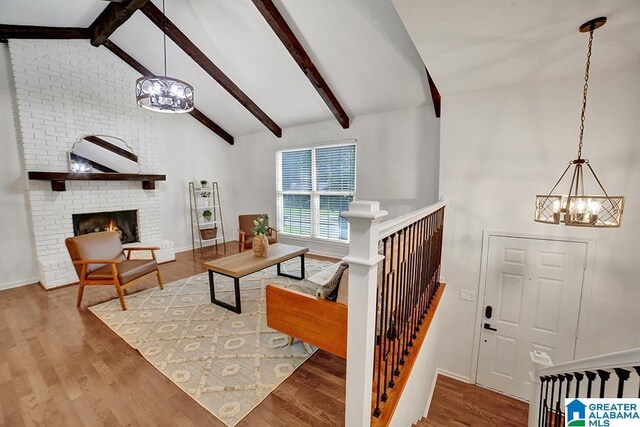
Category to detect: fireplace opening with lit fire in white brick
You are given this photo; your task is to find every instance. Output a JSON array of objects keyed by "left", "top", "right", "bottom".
[{"left": 73, "top": 210, "right": 140, "bottom": 243}]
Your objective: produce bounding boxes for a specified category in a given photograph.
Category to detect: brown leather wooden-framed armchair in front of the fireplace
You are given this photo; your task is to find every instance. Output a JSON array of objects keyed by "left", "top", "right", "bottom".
[{"left": 65, "top": 231, "right": 162, "bottom": 310}]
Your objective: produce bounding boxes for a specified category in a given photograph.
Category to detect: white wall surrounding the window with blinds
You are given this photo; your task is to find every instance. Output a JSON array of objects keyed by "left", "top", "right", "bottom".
[{"left": 232, "top": 105, "right": 439, "bottom": 256}]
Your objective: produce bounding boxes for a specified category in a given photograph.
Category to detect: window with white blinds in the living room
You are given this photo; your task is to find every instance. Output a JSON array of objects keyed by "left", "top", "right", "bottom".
[{"left": 276, "top": 144, "right": 356, "bottom": 241}]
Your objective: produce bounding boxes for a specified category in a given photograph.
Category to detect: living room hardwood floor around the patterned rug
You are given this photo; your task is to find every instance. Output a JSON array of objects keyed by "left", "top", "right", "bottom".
[{"left": 0, "top": 242, "right": 345, "bottom": 427}]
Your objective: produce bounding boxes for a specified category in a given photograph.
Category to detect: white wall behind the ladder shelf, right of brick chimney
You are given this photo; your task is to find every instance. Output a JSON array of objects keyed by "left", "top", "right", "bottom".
[{"left": 158, "top": 114, "right": 238, "bottom": 252}]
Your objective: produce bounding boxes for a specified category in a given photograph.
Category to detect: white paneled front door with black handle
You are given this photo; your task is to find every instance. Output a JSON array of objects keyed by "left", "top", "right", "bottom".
[{"left": 476, "top": 236, "right": 587, "bottom": 400}]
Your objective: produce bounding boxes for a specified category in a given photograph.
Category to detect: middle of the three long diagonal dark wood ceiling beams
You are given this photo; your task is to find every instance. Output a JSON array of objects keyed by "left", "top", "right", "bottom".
[{"left": 140, "top": 2, "right": 282, "bottom": 137}]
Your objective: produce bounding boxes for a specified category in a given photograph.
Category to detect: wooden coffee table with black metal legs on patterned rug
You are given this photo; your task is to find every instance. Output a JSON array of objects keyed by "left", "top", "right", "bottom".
[{"left": 203, "top": 243, "right": 309, "bottom": 313}]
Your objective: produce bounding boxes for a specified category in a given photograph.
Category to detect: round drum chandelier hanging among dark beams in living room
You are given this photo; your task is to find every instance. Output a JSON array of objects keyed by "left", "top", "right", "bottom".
[{"left": 136, "top": 0, "right": 193, "bottom": 113}]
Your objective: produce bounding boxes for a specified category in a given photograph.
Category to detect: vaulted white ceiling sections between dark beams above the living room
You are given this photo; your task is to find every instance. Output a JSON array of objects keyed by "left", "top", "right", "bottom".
[{"left": 0, "top": 0, "right": 431, "bottom": 136}]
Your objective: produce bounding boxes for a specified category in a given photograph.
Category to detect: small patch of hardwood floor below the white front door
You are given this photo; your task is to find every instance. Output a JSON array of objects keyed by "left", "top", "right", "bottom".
[{"left": 416, "top": 375, "right": 529, "bottom": 427}]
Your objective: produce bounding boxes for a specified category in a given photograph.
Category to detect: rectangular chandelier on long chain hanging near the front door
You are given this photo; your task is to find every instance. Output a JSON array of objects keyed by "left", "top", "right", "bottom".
[{"left": 534, "top": 17, "right": 624, "bottom": 228}]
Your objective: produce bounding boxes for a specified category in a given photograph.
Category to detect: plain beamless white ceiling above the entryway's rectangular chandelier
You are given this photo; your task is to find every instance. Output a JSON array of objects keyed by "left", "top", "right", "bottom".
[{"left": 391, "top": 0, "right": 640, "bottom": 96}]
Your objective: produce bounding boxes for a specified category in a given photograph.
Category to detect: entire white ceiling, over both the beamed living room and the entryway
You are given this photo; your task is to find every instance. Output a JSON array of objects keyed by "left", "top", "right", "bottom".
[{"left": 0, "top": 0, "right": 640, "bottom": 136}]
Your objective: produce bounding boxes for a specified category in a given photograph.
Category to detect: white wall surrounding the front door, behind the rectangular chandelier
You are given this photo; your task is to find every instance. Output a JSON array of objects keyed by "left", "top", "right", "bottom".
[{"left": 440, "top": 67, "right": 640, "bottom": 377}]
